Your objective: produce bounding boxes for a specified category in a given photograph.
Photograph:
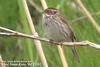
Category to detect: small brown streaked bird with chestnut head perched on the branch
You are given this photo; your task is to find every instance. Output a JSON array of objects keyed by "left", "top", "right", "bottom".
[{"left": 43, "top": 8, "right": 80, "bottom": 62}]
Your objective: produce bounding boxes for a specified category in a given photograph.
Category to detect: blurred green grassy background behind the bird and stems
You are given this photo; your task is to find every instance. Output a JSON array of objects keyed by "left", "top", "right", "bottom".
[{"left": 0, "top": 0, "right": 100, "bottom": 67}]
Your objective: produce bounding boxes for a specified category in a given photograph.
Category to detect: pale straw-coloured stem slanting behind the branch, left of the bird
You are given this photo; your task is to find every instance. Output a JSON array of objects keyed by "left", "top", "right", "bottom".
[{"left": 22, "top": 0, "right": 48, "bottom": 67}]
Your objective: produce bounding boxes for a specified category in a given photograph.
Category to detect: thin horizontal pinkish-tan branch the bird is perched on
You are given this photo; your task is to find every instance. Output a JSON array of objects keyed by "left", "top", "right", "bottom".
[{"left": 0, "top": 32, "right": 100, "bottom": 50}]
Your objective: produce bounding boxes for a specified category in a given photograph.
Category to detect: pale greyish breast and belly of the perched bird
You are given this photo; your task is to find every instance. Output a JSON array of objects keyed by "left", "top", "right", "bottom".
[{"left": 44, "top": 17, "right": 69, "bottom": 41}]
